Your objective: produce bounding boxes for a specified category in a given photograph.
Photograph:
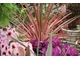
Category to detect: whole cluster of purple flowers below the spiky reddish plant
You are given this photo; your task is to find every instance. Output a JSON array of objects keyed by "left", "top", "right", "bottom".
[{"left": 31, "top": 38, "right": 78, "bottom": 56}]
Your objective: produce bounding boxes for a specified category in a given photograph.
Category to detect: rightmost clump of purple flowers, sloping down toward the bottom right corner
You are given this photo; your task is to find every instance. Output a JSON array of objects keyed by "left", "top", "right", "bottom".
[{"left": 62, "top": 44, "right": 78, "bottom": 56}]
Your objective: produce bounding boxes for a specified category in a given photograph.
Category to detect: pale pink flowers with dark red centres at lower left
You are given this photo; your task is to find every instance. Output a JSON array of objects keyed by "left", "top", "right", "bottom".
[{"left": 0, "top": 28, "right": 34, "bottom": 56}]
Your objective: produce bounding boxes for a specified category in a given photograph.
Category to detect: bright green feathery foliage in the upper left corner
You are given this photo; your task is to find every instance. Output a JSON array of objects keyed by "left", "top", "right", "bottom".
[{"left": 0, "top": 3, "right": 17, "bottom": 27}]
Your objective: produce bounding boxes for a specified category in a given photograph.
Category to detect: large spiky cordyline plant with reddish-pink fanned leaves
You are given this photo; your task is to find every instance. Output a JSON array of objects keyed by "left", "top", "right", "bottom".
[{"left": 10, "top": 4, "right": 80, "bottom": 55}]
